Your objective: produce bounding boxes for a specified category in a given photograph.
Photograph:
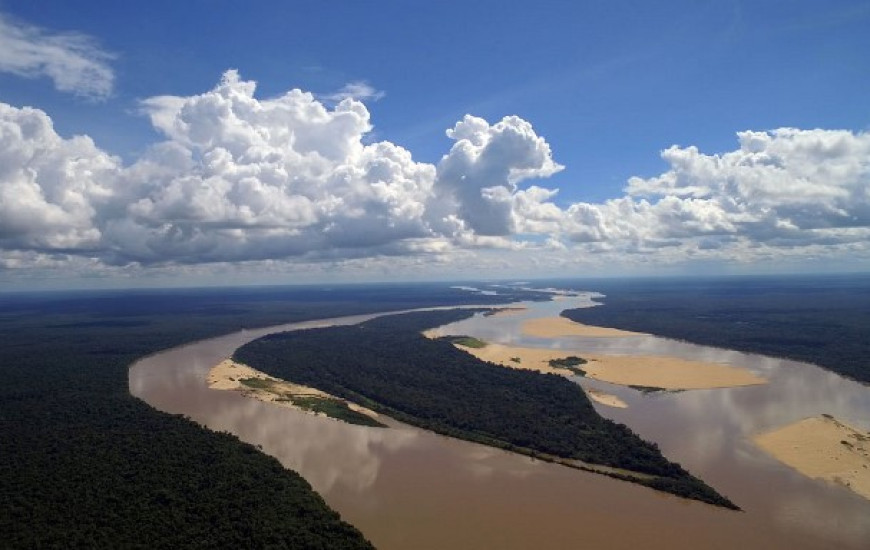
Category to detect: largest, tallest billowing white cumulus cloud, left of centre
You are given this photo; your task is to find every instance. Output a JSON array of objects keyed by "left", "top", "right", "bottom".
[{"left": 120, "top": 71, "right": 434, "bottom": 262}]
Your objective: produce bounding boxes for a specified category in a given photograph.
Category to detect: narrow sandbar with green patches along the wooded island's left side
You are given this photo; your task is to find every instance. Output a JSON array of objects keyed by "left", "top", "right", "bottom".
[{"left": 208, "top": 359, "right": 378, "bottom": 418}]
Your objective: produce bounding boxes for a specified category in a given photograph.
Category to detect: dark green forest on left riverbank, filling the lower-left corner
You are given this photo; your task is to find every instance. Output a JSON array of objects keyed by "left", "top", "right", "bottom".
[{"left": 0, "top": 285, "right": 529, "bottom": 549}]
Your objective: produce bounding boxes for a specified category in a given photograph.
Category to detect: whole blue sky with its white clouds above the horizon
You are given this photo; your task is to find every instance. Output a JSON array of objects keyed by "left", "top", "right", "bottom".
[{"left": 0, "top": 0, "right": 870, "bottom": 291}]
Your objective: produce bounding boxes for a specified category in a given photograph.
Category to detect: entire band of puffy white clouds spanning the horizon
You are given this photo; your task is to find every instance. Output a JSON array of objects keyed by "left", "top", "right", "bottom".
[{"left": 0, "top": 71, "right": 870, "bottom": 280}]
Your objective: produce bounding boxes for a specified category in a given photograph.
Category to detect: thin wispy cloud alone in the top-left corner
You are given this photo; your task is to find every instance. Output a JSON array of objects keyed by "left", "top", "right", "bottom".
[{"left": 0, "top": 14, "right": 115, "bottom": 99}]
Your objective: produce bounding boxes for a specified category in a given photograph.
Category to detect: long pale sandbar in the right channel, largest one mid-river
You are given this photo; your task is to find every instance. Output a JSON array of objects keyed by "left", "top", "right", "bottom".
[{"left": 457, "top": 343, "right": 767, "bottom": 390}]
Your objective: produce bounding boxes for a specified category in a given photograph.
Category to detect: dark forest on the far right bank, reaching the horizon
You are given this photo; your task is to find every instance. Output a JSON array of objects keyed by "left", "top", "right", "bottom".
[{"left": 562, "top": 275, "right": 870, "bottom": 383}]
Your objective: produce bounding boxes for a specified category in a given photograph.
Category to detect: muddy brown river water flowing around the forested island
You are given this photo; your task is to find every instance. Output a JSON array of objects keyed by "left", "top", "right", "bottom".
[{"left": 130, "top": 295, "right": 870, "bottom": 550}]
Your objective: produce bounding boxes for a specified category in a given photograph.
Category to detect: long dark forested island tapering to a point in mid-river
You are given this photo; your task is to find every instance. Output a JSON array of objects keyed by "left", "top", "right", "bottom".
[{"left": 234, "top": 310, "right": 734, "bottom": 508}]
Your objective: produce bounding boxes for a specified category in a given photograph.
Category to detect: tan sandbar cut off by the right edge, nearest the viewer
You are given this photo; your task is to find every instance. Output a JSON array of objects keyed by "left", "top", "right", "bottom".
[{"left": 753, "top": 415, "right": 870, "bottom": 500}]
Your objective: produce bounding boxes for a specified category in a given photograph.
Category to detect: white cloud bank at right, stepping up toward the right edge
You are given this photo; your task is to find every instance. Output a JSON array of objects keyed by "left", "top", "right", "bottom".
[{"left": 566, "top": 128, "right": 870, "bottom": 254}]
